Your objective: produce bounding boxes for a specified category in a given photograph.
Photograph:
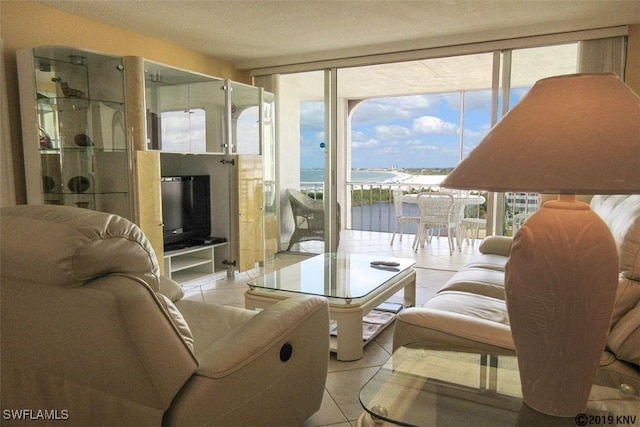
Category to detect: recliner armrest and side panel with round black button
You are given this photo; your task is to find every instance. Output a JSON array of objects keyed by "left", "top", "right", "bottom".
[{"left": 164, "top": 297, "right": 329, "bottom": 425}]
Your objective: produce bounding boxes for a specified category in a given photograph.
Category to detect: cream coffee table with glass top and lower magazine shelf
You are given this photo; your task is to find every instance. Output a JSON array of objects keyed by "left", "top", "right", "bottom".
[{"left": 245, "top": 252, "right": 416, "bottom": 361}]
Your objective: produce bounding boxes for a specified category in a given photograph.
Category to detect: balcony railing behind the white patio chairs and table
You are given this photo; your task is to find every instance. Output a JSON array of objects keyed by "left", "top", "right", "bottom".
[{"left": 300, "top": 182, "right": 538, "bottom": 235}]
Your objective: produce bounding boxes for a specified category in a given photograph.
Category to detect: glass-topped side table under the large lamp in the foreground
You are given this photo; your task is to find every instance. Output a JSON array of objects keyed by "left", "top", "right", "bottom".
[{"left": 356, "top": 347, "right": 640, "bottom": 427}]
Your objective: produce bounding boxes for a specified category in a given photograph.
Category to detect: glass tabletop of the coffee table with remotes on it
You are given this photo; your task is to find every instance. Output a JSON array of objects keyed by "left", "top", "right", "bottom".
[{"left": 248, "top": 252, "right": 415, "bottom": 302}]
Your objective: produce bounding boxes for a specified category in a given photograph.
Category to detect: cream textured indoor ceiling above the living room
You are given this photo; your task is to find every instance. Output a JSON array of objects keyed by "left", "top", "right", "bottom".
[{"left": 41, "top": 0, "right": 640, "bottom": 69}]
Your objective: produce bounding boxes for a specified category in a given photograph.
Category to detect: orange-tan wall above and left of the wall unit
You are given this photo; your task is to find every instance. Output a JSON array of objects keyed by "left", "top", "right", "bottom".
[{"left": 0, "top": 0, "right": 251, "bottom": 204}]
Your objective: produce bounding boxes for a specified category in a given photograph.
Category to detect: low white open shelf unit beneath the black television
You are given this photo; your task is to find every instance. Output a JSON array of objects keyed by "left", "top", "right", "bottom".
[{"left": 164, "top": 242, "right": 227, "bottom": 284}]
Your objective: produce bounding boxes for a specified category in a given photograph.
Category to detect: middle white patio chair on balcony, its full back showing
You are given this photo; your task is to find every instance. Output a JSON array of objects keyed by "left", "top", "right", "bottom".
[{"left": 413, "top": 192, "right": 459, "bottom": 255}]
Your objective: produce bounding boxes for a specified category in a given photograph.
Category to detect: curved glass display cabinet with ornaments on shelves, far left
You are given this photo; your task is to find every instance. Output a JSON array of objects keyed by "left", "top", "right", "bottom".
[{"left": 17, "top": 47, "right": 133, "bottom": 219}]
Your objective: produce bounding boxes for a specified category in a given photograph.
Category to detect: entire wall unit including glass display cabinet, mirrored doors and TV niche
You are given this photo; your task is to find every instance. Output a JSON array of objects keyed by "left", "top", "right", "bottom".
[{"left": 18, "top": 47, "right": 273, "bottom": 281}]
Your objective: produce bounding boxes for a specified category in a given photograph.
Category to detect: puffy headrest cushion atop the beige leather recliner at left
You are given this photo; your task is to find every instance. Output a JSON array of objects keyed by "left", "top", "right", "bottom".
[{"left": 1, "top": 205, "right": 159, "bottom": 291}]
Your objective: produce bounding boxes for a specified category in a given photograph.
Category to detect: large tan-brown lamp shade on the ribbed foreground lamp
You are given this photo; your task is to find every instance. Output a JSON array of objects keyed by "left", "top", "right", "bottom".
[{"left": 442, "top": 74, "right": 640, "bottom": 194}]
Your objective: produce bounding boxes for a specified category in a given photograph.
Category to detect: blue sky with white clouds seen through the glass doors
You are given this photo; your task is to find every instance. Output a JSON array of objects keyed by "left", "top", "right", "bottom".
[{"left": 300, "top": 89, "right": 526, "bottom": 169}]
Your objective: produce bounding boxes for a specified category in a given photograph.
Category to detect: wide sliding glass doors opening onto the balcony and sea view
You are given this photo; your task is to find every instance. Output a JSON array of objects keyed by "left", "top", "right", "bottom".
[{"left": 255, "top": 33, "right": 624, "bottom": 252}]
